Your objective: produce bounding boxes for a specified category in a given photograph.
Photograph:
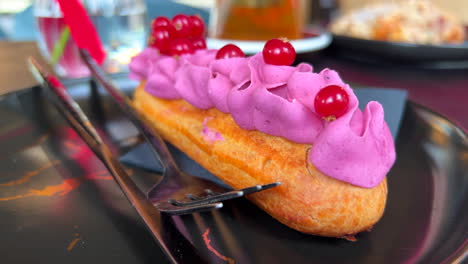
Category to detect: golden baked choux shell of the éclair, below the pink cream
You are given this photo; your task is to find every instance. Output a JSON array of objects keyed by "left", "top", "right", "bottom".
[{"left": 134, "top": 82, "right": 387, "bottom": 237}]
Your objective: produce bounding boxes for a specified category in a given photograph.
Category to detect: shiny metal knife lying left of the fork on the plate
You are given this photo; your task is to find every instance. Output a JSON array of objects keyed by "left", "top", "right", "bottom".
[{"left": 28, "top": 57, "right": 208, "bottom": 263}]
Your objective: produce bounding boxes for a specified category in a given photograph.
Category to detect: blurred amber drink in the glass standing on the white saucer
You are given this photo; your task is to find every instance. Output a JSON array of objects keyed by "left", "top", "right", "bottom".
[{"left": 215, "top": 0, "right": 303, "bottom": 40}]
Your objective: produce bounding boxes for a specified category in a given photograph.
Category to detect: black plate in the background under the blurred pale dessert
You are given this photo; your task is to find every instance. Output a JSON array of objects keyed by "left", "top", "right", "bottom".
[{"left": 332, "top": 35, "right": 468, "bottom": 67}]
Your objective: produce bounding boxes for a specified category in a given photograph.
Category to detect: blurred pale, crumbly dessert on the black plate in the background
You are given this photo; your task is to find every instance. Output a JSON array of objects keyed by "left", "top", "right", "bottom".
[{"left": 330, "top": 0, "right": 465, "bottom": 45}]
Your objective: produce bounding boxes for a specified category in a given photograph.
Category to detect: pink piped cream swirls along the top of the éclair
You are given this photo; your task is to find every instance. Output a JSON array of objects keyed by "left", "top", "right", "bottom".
[{"left": 130, "top": 48, "right": 395, "bottom": 188}]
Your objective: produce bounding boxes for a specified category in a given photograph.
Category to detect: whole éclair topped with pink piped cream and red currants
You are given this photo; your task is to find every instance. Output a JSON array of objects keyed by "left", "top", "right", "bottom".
[{"left": 130, "top": 14, "right": 395, "bottom": 237}]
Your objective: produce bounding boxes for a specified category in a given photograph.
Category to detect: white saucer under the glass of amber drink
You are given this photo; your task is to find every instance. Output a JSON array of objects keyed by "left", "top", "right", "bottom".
[{"left": 206, "top": 33, "right": 332, "bottom": 54}]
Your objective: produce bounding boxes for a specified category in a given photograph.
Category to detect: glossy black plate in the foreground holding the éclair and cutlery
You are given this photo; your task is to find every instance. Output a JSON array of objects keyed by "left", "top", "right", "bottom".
[{"left": 0, "top": 77, "right": 468, "bottom": 264}]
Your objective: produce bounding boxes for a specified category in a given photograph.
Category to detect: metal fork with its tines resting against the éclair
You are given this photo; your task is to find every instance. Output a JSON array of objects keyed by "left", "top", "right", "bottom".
[{"left": 80, "top": 49, "right": 280, "bottom": 215}]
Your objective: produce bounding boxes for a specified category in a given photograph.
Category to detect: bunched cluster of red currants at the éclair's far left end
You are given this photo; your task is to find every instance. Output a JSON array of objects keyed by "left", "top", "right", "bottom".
[{"left": 149, "top": 14, "right": 206, "bottom": 56}]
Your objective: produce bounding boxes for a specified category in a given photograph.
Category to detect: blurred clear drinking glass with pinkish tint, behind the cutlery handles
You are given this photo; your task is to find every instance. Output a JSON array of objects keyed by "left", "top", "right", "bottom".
[{"left": 34, "top": 0, "right": 146, "bottom": 78}]
